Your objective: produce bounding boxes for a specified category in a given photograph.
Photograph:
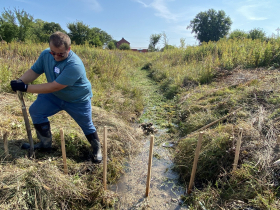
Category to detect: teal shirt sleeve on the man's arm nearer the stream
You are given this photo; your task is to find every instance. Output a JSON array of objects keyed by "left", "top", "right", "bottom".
[{"left": 55, "top": 64, "right": 85, "bottom": 86}]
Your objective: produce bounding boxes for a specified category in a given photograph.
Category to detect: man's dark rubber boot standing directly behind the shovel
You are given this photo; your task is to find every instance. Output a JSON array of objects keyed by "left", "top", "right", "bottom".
[{"left": 21, "top": 122, "right": 52, "bottom": 150}]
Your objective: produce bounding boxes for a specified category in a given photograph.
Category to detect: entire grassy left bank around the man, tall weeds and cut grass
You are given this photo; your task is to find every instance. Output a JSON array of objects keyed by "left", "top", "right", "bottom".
[{"left": 0, "top": 43, "right": 147, "bottom": 209}]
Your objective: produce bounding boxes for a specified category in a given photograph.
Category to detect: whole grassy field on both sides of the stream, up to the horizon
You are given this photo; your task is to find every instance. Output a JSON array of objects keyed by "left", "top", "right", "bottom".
[{"left": 0, "top": 39, "right": 280, "bottom": 209}]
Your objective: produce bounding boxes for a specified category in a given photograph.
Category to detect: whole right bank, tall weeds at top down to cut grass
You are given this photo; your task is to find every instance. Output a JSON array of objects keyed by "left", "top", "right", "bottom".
[{"left": 143, "top": 38, "right": 280, "bottom": 209}]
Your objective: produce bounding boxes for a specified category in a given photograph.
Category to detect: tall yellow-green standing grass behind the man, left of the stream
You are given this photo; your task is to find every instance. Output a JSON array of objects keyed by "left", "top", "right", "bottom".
[{"left": 0, "top": 42, "right": 145, "bottom": 116}]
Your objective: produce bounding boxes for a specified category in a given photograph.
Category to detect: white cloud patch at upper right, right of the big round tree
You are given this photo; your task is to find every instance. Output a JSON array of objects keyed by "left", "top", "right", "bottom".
[{"left": 237, "top": 1, "right": 268, "bottom": 21}]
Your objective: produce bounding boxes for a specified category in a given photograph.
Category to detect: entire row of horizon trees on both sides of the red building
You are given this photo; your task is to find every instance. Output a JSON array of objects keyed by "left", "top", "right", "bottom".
[{"left": 0, "top": 8, "right": 274, "bottom": 52}]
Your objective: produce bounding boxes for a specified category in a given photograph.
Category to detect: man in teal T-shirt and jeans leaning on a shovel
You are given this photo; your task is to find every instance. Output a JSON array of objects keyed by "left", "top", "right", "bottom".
[{"left": 11, "top": 32, "right": 102, "bottom": 163}]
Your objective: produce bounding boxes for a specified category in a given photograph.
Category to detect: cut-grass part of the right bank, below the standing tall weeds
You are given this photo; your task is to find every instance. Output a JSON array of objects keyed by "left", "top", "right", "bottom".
[{"left": 175, "top": 68, "right": 280, "bottom": 209}]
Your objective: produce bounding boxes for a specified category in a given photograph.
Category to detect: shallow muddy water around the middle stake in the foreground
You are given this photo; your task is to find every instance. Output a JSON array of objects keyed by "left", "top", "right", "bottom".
[{"left": 109, "top": 127, "right": 188, "bottom": 210}]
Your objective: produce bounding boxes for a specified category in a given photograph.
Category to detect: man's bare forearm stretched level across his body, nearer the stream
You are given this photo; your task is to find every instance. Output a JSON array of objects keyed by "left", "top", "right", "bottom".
[{"left": 27, "top": 81, "right": 67, "bottom": 93}]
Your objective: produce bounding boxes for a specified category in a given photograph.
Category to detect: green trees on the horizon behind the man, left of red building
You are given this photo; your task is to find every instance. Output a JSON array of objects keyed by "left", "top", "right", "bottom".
[{"left": 0, "top": 8, "right": 117, "bottom": 49}]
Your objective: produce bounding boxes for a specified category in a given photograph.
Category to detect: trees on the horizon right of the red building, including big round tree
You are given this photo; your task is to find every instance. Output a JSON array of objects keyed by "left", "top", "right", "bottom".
[{"left": 149, "top": 9, "right": 270, "bottom": 51}]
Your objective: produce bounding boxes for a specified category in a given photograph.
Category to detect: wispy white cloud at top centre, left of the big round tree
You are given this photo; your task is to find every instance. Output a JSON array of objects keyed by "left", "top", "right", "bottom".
[{"left": 135, "top": 0, "right": 180, "bottom": 21}]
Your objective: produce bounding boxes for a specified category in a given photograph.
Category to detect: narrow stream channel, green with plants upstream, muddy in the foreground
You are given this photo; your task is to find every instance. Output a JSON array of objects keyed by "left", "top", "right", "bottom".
[{"left": 109, "top": 70, "right": 187, "bottom": 210}]
